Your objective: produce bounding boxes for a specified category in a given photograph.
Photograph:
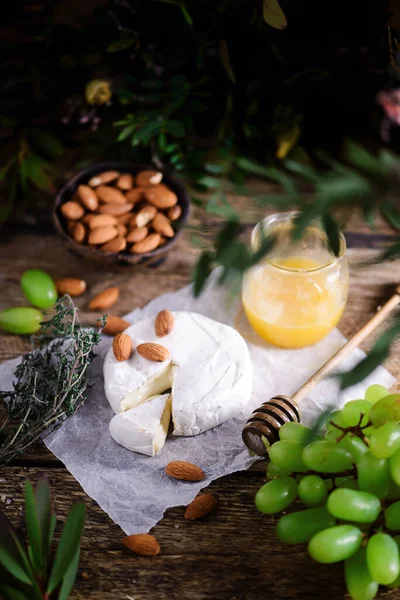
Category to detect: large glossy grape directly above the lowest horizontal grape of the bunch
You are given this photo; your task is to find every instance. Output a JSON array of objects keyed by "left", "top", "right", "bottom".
[{"left": 326, "top": 489, "right": 381, "bottom": 523}]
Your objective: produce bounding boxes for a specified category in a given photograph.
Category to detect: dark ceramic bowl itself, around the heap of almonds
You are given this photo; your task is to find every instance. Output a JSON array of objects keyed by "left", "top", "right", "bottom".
[{"left": 53, "top": 162, "right": 190, "bottom": 266}]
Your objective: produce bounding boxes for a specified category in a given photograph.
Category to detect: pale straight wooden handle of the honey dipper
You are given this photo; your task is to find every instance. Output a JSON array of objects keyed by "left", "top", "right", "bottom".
[{"left": 291, "top": 286, "right": 400, "bottom": 403}]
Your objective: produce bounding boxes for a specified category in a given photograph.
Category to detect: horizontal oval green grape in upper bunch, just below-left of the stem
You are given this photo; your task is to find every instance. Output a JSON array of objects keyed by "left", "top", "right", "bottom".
[{"left": 302, "top": 440, "right": 354, "bottom": 473}]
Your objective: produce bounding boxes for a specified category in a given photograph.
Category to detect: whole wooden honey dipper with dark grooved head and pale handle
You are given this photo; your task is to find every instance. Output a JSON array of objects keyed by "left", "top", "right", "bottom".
[{"left": 242, "top": 285, "right": 400, "bottom": 456}]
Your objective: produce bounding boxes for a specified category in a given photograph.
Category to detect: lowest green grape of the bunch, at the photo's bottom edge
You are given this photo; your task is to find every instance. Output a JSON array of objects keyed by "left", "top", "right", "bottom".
[{"left": 344, "top": 548, "right": 378, "bottom": 600}]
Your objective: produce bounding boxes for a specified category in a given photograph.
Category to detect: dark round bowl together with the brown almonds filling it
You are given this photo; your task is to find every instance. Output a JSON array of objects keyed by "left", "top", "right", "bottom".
[{"left": 53, "top": 162, "right": 190, "bottom": 266}]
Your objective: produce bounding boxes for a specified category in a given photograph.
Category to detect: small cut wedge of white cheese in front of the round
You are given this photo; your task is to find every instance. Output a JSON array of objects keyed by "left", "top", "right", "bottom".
[{"left": 110, "top": 394, "right": 171, "bottom": 456}]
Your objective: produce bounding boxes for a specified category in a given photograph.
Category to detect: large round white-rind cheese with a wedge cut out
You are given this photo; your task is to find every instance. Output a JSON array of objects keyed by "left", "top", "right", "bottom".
[{"left": 104, "top": 312, "right": 252, "bottom": 436}]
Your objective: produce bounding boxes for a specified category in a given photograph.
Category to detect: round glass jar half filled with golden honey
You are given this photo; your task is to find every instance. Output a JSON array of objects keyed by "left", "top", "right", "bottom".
[{"left": 242, "top": 211, "right": 349, "bottom": 348}]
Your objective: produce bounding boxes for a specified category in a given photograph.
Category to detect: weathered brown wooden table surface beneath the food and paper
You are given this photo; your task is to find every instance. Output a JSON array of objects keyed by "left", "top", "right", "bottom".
[{"left": 0, "top": 198, "right": 400, "bottom": 600}]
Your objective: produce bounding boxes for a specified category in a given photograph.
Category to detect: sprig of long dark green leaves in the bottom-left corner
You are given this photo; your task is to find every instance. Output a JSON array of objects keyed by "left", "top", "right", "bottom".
[{"left": 0, "top": 478, "right": 85, "bottom": 600}]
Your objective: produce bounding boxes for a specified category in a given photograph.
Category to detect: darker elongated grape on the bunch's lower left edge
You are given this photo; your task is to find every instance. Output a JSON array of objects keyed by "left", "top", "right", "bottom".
[{"left": 276, "top": 508, "right": 336, "bottom": 544}]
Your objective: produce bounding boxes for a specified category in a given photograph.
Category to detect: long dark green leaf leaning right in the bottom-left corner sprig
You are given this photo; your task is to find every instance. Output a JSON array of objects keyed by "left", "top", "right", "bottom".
[{"left": 46, "top": 504, "right": 85, "bottom": 594}]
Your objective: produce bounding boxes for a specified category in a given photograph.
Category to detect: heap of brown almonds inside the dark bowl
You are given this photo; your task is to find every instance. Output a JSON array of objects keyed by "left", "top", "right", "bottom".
[{"left": 60, "top": 171, "right": 182, "bottom": 254}]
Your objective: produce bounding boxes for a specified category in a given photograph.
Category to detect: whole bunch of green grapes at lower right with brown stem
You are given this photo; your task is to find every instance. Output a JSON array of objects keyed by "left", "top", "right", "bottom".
[{"left": 255, "top": 385, "right": 400, "bottom": 600}]
